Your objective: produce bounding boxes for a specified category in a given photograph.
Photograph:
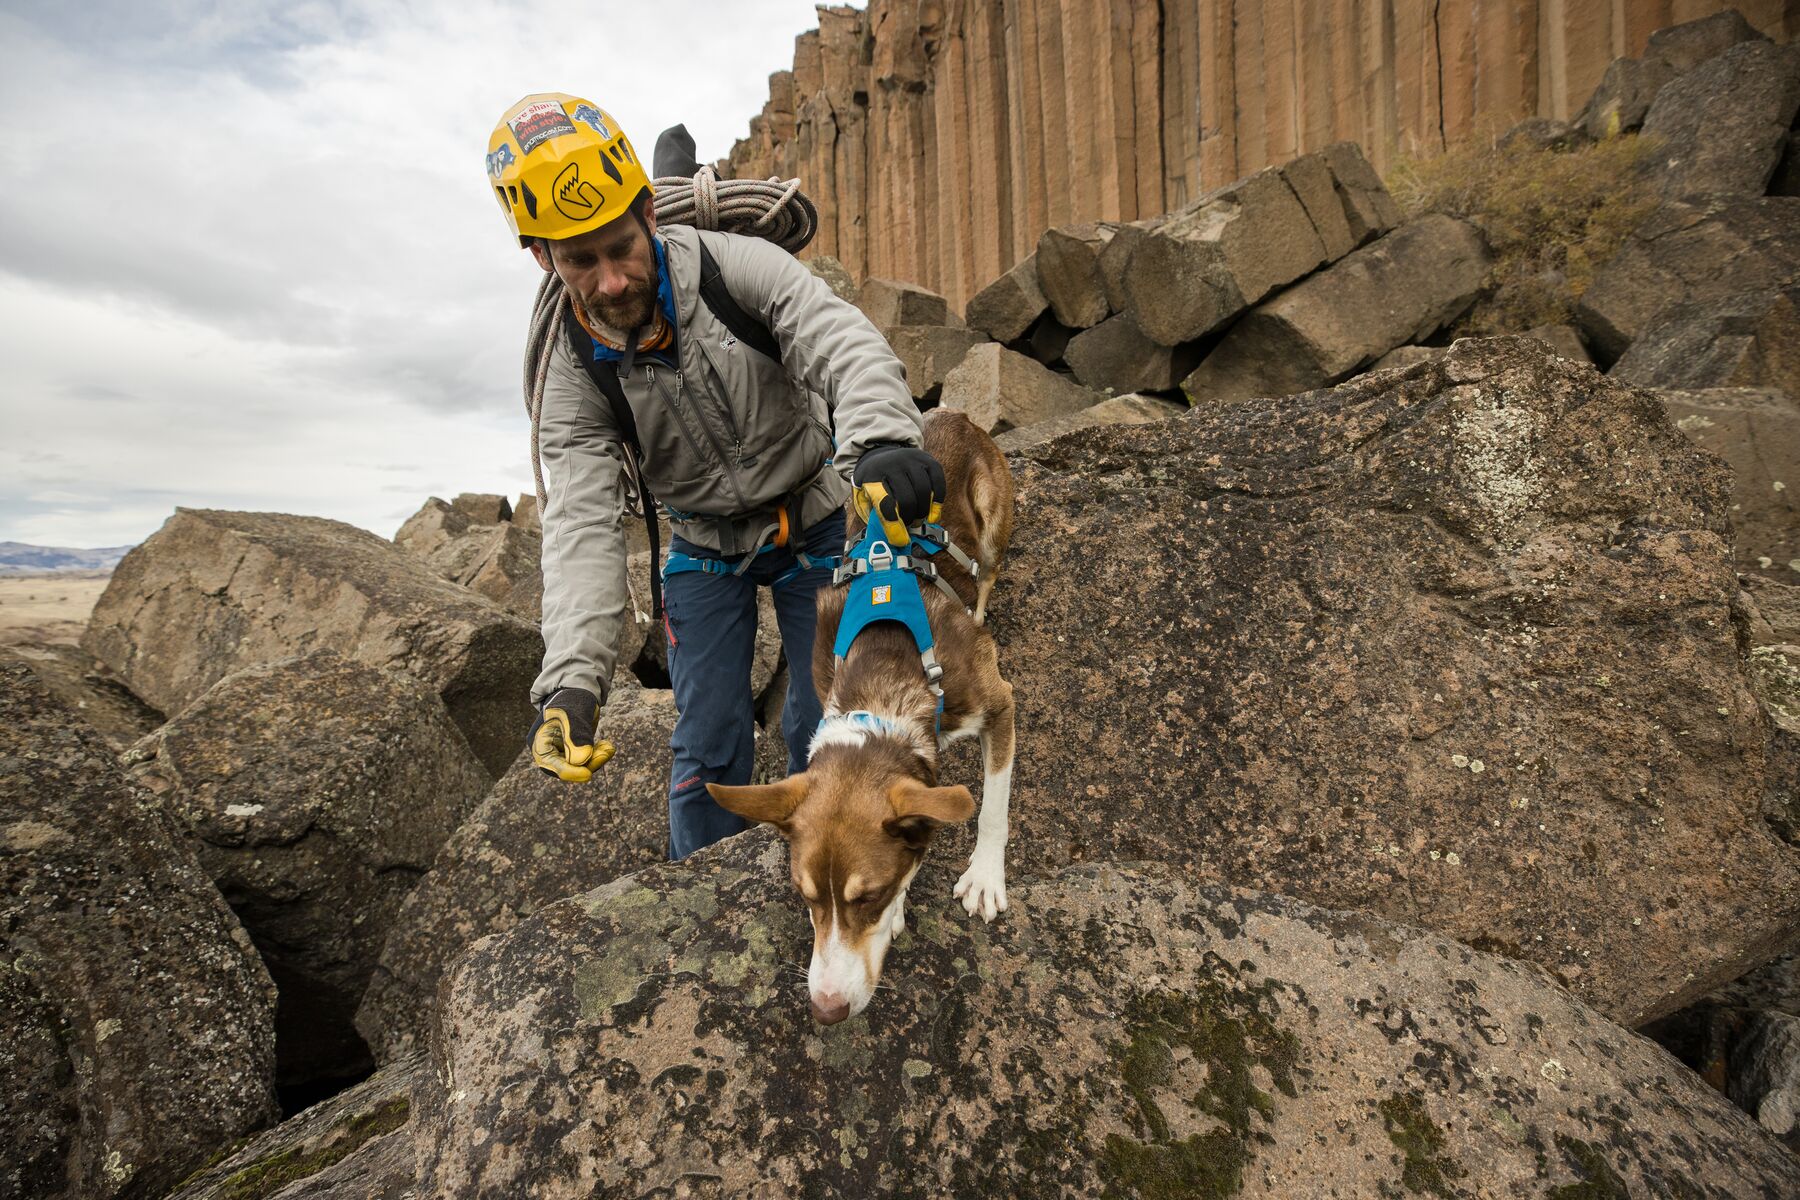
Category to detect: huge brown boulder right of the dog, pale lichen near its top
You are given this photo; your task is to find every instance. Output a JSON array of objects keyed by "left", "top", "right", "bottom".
[{"left": 988, "top": 338, "right": 1800, "bottom": 1024}]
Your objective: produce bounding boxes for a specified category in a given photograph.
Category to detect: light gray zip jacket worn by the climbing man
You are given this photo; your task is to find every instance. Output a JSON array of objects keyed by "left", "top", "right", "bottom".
[{"left": 531, "top": 225, "right": 922, "bottom": 703}]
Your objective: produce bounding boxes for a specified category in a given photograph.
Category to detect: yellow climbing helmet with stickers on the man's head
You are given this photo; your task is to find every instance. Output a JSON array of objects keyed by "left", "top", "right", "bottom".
[{"left": 488, "top": 92, "right": 652, "bottom": 246}]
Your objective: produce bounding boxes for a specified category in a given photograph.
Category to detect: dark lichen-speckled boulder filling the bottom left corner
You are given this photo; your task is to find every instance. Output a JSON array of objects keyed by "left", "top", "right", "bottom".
[{"left": 0, "top": 658, "right": 277, "bottom": 1200}]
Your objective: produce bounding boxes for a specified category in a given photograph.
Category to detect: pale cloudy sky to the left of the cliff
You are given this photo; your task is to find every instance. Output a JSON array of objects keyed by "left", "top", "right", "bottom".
[{"left": 0, "top": 0, "right": 835, "bottom": 547}]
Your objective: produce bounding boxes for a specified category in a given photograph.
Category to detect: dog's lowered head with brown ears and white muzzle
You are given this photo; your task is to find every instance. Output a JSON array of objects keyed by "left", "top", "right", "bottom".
[{"left": 706, "top": 766, "right": 976, "bottom": 1025}]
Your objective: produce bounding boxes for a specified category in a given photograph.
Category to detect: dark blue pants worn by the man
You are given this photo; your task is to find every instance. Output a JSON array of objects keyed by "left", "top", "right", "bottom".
[{"left": 662, "top": 513, "right": 844, "bottom": 860}]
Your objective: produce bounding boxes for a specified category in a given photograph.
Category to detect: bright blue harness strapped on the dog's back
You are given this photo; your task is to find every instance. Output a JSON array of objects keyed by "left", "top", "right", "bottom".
[{"left": 832, "top": 482, "right": 981, "bottom": 738}]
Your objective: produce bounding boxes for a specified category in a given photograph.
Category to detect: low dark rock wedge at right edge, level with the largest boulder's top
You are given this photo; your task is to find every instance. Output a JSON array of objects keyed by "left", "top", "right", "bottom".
[{"left": 1609, "top": 288, "right": 1800, "bottom": 396}]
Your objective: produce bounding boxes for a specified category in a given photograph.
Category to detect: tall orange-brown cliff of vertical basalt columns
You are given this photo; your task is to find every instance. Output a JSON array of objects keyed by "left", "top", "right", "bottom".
[{"left": 724, "top": 0, "right": 1800, "bottom": 311}]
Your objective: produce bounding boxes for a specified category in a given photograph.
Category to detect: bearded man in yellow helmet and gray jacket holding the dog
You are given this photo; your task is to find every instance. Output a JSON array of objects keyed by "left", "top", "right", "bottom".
[{"left": 488, "top": 94, "right": 943, "bottom": 858}]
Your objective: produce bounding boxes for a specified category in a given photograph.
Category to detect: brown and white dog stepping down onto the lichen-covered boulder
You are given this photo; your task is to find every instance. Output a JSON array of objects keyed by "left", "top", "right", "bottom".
[{"left": 707, "top": 410, "right": 1013, "bottom": 1025}]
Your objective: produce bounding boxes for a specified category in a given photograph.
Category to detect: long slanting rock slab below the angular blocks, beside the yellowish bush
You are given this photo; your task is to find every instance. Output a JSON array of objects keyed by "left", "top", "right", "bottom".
[{"left": 1183, "top": 212, "right": 1492, "bottom": 403}]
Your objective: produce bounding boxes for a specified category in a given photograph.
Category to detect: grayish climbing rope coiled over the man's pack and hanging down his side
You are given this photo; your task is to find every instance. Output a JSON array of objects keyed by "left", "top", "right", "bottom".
[{"left": 526, "top": 167, "right": 819, "bottom": 516}]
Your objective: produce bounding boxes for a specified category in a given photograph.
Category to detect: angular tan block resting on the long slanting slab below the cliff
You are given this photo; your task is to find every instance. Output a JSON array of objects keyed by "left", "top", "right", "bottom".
[{"left": 1114, "top": 167, "right": 1325, "bottom": 345}]
